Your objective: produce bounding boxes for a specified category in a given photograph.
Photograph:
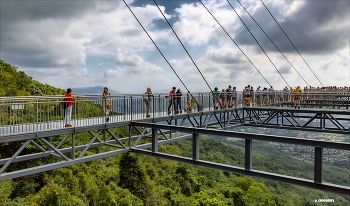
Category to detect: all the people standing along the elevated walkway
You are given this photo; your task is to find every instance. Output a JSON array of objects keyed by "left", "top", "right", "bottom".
[{"left": 63, "top": 85, "right": 350, "bottom": 127}]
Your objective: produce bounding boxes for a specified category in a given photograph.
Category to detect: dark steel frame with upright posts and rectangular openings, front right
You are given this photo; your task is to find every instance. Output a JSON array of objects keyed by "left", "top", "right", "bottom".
[{"left": 131, "top": 122, "right": 350, "bottom": 195}]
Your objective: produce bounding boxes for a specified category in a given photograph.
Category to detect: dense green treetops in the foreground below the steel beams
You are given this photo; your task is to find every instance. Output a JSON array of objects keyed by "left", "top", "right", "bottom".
[{"left": 0, "top": 136, "right": 350, "bottom": 206}]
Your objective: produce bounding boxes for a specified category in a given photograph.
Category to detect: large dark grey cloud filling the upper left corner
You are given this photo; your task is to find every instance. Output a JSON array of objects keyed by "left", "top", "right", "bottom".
[{"left": 0, "top": 0, "right": 122, "bottom": 68}]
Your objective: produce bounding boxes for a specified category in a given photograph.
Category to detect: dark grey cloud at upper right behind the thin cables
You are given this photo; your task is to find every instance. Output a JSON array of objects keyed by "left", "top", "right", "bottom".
[{"left": 231, "top": 1, "right": 350, "bottom": 54}]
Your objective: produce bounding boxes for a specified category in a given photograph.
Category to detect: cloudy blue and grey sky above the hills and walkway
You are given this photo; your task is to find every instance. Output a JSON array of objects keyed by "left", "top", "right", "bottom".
[{"left": 0, "top": 0, "right": 350, "bottom": 93}]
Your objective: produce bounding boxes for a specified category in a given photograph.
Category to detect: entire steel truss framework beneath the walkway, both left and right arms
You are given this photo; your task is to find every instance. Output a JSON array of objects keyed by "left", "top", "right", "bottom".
[{"left": 0, "top": 107, "right": 350, "bottom": 194}]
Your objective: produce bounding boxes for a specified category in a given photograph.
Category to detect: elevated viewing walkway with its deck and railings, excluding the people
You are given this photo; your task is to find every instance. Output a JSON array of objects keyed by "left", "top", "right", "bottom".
[{"left": 0, "top": 92, "right": 350, "bottom": 137}]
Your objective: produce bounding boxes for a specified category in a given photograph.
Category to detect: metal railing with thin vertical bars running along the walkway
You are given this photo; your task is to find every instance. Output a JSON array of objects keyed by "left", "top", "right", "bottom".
[{"left": 0, "top": 91, "right": 350, "bottom": 136}]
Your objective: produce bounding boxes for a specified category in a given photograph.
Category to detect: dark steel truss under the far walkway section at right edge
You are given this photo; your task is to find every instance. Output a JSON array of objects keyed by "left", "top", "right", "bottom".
[{"left": 244, "top": 108, "right": 350, "bottom": 134}]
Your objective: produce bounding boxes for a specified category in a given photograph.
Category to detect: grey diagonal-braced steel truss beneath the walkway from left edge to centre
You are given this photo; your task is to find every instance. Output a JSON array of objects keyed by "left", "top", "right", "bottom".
[{"left": 0, "top": 110, "right": 238, "bottom": 181}]
